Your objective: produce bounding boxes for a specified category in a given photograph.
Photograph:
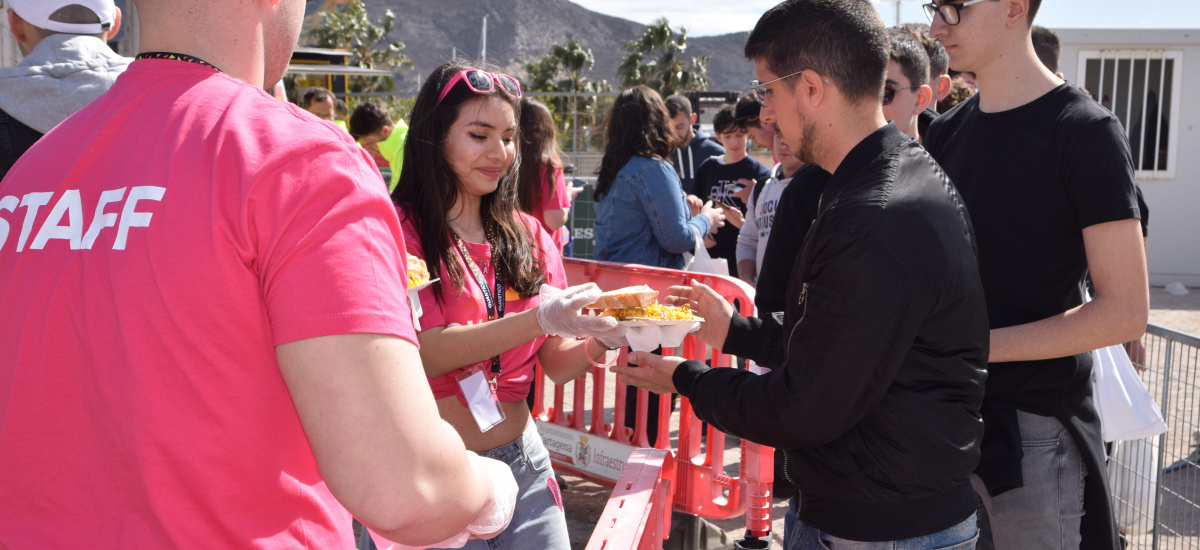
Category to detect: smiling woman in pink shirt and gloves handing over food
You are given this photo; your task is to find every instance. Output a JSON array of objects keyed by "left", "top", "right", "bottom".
[{"left": 392, "top": 62, "right": 619, "bottom": 550}]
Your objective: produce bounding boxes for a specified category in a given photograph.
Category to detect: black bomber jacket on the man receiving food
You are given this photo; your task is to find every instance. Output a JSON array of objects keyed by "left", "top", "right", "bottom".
[{"left": 674, "top": 125, "right": 988, "bottom": 540}]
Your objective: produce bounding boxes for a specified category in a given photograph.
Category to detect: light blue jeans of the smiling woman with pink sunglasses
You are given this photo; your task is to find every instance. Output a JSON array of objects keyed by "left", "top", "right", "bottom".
[{"left": 359, "top": 423, "right": 571, "bottom": 550}]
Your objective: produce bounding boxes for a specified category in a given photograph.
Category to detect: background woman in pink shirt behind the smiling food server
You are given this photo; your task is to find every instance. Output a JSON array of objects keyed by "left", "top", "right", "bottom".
[{"left": 517, "top": 97, "right": 572, "bottom": 247}]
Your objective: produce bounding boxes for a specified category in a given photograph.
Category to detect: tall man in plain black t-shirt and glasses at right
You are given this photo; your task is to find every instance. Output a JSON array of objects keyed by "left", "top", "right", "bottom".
[{"left": 925, "top": 0, "right": 1150, "bottom": 550}]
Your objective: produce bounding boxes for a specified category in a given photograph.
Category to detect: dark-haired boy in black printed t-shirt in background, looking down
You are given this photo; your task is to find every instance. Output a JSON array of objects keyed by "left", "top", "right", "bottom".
[{"left": 692, "top": 106, "right": 770, "bottom": 277}]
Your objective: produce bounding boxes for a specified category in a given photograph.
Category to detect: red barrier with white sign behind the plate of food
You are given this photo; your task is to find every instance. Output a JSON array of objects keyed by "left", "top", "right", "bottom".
[{"left": 534, "top": 258, "right": 774, "bottom": 542}]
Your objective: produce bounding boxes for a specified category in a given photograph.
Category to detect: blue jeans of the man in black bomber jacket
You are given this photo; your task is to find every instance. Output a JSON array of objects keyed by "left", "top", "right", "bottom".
[{"left": 784, "top": 498, "right": 979, "bottom": 550}]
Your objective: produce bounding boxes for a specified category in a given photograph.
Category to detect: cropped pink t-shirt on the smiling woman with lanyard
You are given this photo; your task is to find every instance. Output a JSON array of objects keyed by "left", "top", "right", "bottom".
[{"left": 401, "top": 213, "right": 566, "bottom": 405}]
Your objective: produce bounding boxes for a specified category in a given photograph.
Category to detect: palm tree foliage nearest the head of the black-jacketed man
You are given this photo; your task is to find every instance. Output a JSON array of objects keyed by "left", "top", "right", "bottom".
[{"left": 617, "top": 17, "right": 708, "bottom": 97}]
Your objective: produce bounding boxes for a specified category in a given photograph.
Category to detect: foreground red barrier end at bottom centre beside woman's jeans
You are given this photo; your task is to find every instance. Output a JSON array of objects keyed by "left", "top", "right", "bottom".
[{"left": 587, "top": 449, "right": 674, "bottom": 550}]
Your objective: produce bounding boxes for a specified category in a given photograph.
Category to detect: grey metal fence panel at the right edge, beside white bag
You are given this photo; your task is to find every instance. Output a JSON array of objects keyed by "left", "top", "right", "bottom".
[{"left": 1108, "top": 324, "right": 1200, "bottom": 550}]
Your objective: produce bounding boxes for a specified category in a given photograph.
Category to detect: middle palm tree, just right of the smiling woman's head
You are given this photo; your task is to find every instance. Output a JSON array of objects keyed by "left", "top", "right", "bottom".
[{"left": 524, "top": 38, "right": 612, "bottom": 151}]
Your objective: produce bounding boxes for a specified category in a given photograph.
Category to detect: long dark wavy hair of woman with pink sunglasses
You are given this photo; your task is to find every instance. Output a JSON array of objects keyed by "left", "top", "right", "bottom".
[{"left": 391, "top": 61, "right": 546, "bottom": 300}]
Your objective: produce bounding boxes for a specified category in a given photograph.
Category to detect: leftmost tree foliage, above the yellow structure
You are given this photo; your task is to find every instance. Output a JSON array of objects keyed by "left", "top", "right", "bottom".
[{"left": 305, "top": 0, "right": 416, "bottom": 92}]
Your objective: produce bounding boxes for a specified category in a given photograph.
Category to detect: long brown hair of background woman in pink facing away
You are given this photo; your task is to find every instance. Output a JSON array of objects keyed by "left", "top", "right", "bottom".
[{"left": 517, "top": 97, "right": 563, "bottom": 216}]
